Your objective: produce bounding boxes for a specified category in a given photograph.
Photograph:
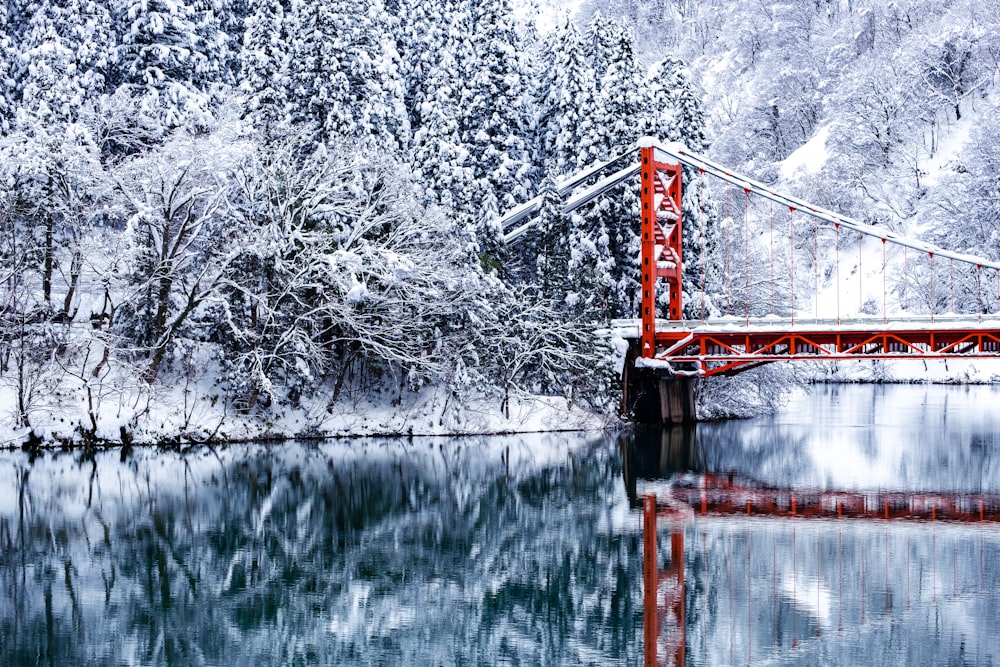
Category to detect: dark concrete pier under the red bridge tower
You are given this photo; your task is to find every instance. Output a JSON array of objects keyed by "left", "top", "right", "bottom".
[{"left": 621, "top": 344, "right": 698, "bottom": 426}]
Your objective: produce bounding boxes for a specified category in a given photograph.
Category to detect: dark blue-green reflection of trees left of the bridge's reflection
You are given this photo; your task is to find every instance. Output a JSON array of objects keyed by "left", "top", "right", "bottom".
[{"left": 0, "top": 436, "right": 642, "bottom": 664}]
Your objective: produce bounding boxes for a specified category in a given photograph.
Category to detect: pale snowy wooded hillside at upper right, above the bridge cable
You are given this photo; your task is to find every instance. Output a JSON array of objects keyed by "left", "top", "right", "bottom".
[{"left": 580, "top": 0, "right": 1000, "bottom": 294}]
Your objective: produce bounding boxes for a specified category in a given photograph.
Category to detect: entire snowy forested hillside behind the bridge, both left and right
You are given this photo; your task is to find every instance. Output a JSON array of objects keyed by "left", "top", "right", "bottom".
[{"left": 0, "top": 0, "right": 1000, "bottom": 441}]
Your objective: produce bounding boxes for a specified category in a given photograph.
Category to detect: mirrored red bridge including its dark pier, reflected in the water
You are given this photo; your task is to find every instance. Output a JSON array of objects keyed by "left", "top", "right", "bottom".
[{"left": 621, "top": 426, "right": 1000, "bottom": 666}]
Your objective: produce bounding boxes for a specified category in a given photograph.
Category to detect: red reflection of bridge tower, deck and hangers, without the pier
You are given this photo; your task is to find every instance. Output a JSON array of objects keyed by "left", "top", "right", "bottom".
[{"left": 642, "top": 475, "right": 1000, "bottom": 667}]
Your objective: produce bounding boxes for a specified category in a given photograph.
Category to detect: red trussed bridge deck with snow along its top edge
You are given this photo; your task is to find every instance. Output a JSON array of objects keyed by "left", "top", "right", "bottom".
[{"left": 613, "top": 315, "right": 1000, "bottom": 376}]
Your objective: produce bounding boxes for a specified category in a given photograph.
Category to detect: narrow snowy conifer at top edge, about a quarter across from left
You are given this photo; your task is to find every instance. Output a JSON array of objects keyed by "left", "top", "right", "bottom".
[{"left": 240, "top": 0, "right": 288, "bottom": 143}]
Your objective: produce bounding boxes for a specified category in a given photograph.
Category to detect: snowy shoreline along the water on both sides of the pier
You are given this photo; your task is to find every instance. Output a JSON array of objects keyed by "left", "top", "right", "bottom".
[{"left": 9, "top": 359, "right": 1000, "bottom": 449}]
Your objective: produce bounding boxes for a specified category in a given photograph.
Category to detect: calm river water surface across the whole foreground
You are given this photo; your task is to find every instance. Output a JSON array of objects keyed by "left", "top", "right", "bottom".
[{"left": 0, "top": 386, "right": 1000, "bottom": 665}]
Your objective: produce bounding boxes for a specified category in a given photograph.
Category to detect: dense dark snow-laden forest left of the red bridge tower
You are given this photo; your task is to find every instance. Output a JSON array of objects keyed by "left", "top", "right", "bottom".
[{"left": 0, "top": 0, "right": 704, "bottom": 448}]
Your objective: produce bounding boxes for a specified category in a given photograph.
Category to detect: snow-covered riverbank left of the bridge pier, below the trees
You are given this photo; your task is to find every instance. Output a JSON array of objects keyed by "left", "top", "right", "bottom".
[{"left": 0, "top": 384, "right": 611, "bottom": 448}]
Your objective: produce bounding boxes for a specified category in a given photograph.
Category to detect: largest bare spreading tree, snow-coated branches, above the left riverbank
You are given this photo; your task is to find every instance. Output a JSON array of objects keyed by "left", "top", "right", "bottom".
[{"left": 219, "top": 142, "right": 488, "bottom": 410}]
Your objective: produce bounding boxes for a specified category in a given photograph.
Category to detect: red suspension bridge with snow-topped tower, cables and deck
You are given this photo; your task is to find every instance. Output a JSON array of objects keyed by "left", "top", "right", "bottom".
[{"left": 500, "top": 138, "right": 1000, "bottom": 377}]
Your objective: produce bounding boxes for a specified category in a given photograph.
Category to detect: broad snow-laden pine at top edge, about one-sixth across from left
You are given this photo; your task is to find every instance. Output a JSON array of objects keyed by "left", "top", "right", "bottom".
[{"left": 111, "top": 0, "right": 227, "bottom": 133}]
